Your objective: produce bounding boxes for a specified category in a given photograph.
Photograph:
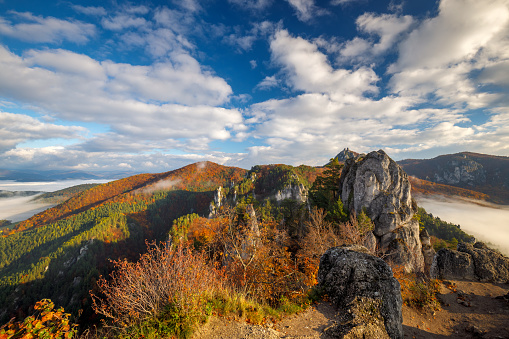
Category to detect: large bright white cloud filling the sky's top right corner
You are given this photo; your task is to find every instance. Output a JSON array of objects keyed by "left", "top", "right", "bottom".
[{"left": 389, "top": 0, "right": 509, "bottom": 109}]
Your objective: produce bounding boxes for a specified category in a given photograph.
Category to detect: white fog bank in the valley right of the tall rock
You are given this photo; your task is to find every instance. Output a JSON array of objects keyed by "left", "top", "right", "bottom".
[{"left": 416, "top": 197, "right": 509, "bottom": 255}]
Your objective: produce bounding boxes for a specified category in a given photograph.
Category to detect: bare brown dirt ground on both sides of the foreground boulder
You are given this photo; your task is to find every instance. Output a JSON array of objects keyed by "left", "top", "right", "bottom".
[{"left": 193, "top": 281, "right": 509, "bottom": 339}]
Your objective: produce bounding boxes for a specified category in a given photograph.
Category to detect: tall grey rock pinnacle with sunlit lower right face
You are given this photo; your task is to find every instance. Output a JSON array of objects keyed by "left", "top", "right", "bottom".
[{"left": 339, "top": 150, "right": 424, "bottom": 271}]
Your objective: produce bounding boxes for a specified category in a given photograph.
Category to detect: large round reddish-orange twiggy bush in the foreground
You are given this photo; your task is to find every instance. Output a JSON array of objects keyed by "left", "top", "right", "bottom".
[{"left": 92, "top": 244, "right": 224, "bottom": 337}]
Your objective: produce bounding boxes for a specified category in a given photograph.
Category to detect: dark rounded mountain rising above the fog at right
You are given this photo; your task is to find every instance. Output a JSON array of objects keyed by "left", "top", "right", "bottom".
[{"left": 398, "top": 152, "right": 509, "bottom": 204}]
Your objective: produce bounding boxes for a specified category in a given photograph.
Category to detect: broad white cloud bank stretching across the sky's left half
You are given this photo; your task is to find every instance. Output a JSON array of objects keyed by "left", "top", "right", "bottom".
[{"left": 0, "top": 47, "right": 237, "bottom": 153}]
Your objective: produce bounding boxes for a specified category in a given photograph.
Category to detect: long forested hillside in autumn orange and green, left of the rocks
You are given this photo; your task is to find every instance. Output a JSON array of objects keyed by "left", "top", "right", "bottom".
[{"left": 0, "top": 162, "right": 321, "bottom": 322}]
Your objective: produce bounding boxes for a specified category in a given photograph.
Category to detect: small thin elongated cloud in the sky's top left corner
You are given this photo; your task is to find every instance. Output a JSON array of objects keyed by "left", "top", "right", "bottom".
[{"left": 0, "top": 12, "right": 96, "bottom": 43}]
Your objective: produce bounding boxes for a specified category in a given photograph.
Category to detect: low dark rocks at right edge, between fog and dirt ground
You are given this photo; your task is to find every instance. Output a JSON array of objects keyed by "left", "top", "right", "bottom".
[{"left": 431, "top": 242, "right": 509, "bottom": 283}]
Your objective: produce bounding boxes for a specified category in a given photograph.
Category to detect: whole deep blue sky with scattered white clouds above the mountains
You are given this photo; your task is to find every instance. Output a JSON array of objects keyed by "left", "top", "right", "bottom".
[{"left": 0, "top": 0, "right": 509, "bottom": 172}]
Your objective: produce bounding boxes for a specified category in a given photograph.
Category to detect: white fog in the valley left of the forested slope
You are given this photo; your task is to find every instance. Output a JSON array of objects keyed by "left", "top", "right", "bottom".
[{"left": 0, "top": 180, "right": 111, "bottom": 222}]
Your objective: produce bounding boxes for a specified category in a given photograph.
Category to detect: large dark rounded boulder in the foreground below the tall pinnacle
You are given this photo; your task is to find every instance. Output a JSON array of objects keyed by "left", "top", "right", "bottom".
[{"left": 318, "top": 245, "right": 403, "bottom": 338}]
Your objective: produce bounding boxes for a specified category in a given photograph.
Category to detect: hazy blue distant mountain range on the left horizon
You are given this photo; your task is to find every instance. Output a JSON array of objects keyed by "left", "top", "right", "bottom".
[{"left": 0, "top": 169, "right": 136, "bottom": 182}]
